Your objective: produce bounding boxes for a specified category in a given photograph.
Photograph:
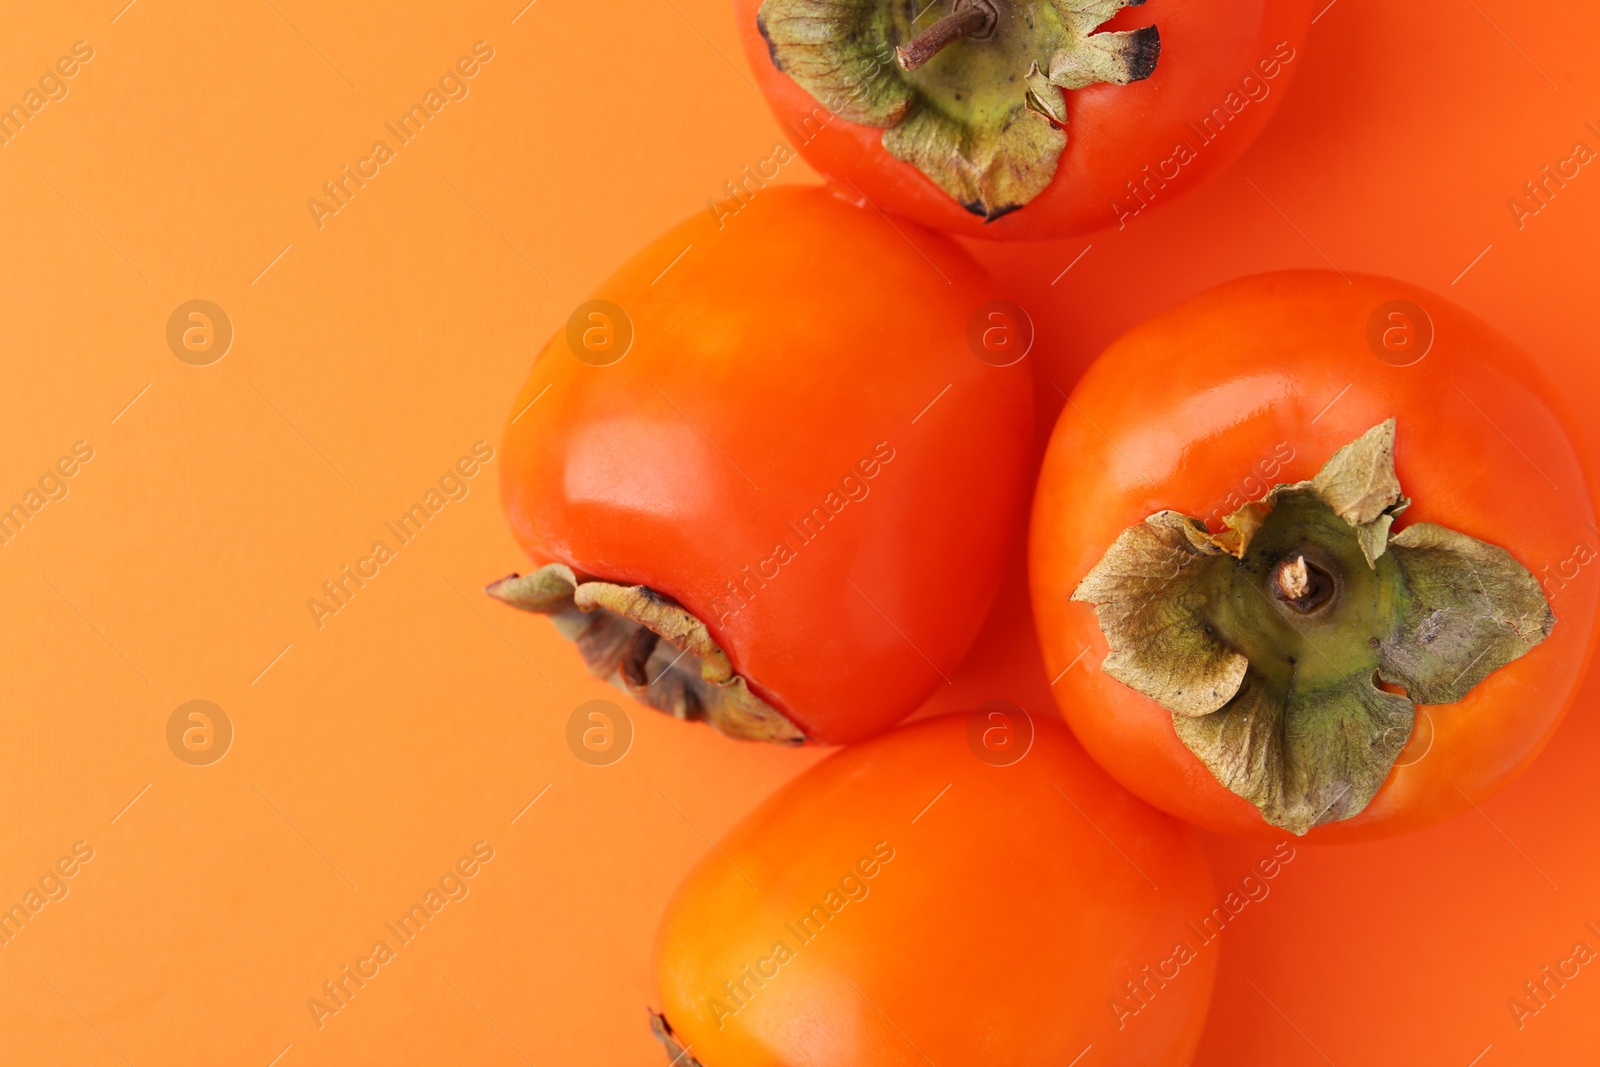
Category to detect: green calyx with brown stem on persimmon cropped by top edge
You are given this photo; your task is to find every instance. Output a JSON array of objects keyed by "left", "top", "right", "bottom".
[{"left": 757, "top": 0, "right": 1162, "bottom": 222}]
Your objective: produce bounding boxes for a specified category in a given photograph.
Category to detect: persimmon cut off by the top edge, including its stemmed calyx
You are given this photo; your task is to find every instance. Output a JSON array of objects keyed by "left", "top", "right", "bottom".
[{"left": 734, "top": 0, "right": 1312, "bottom": 240}]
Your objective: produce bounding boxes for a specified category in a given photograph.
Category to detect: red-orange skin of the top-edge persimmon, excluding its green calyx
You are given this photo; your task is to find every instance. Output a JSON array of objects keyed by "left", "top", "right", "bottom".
[{"left": 733, "top": 0, "right": 1312, "bottom": 240}]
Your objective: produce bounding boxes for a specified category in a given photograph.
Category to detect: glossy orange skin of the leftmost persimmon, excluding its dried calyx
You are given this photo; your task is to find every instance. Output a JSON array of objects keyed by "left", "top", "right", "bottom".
[{"left": 501, "top": 187, "right": 1032, "bottom": 742}]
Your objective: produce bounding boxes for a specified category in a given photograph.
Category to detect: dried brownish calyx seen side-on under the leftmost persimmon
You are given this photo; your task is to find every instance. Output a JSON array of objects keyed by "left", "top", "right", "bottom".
[{"left": 483, "top": 563, "right": 805, "bottom": 744}]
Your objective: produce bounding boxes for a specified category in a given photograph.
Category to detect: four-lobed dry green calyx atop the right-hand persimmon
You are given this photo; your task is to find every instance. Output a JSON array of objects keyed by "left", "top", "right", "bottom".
[{"left": 1072, "top": 419, "right": 1555, "bottom": 833}]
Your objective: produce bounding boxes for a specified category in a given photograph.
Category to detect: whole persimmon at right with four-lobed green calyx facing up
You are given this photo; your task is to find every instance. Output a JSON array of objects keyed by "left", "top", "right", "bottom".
[{"left": 1030, "top": 272, "right": 1595, "bottom": 840}]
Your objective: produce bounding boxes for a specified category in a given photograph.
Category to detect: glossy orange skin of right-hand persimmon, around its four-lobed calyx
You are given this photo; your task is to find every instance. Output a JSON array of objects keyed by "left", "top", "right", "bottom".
[{"left": 1029, "top": 272, "right": 1597, "bottom": 841}]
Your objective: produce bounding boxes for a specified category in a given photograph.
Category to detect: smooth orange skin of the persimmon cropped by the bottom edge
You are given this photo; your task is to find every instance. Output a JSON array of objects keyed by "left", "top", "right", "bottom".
[{"left": 656, "top": 715, "right": 1218, "bottom": 1067}]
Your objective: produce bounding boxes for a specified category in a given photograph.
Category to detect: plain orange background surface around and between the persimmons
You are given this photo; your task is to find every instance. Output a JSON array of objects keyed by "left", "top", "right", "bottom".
[{"left": 0, "top": 0, "right": 1600, "bottom": 1067}]
